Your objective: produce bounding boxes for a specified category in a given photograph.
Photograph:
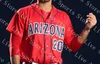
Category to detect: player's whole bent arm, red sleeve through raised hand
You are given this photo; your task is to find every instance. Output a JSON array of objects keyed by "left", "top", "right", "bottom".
[{"left": 64, "top": 13, "right": 97, "bottom": 52}]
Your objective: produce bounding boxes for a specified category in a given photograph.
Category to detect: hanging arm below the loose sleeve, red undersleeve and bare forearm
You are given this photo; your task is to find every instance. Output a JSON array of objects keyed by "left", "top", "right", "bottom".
[{"left": 9, "top": 33, "right": 21, "bottom": 64}]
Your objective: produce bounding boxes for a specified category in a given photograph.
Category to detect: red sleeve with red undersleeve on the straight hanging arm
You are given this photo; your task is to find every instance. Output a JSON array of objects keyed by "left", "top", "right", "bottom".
[{"left": 6, "top": 10, "right": 24, "bottom": 56}]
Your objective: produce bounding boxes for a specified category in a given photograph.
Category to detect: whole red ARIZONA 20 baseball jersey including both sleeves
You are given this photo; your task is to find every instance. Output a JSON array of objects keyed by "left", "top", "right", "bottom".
[{"left": 6, "top": 3, "right": 82, "bottom": 64}]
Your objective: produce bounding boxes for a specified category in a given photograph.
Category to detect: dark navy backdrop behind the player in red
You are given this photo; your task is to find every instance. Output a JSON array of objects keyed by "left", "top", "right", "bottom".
[{"left": 0, "top": 0, "right": 100, "bottom": 64}]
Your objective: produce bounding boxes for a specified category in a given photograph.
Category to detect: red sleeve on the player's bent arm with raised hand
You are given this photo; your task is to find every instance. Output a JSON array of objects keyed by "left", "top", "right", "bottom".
[{"left": 64, "top": 14, "right": 82, "bottom": 52}]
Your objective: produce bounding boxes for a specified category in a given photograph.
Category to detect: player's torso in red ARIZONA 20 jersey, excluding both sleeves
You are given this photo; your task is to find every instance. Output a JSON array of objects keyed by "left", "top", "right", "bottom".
[{"left": 21, "top": 4, "right": 65, "bottom": 64}]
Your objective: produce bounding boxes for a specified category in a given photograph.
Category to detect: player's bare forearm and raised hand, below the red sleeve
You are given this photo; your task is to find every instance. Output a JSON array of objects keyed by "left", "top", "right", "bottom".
[{"left": 78, "top": 13, "right": 97, "bottom": 43}]
